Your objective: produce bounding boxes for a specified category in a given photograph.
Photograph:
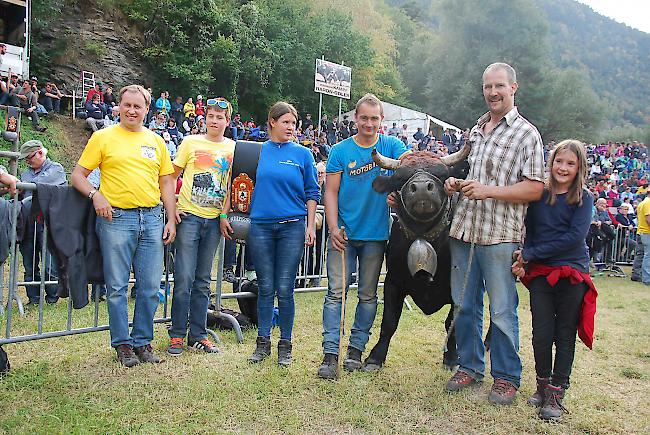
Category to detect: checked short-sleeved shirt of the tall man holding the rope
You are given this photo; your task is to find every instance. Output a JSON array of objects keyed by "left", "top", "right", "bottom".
[{"left": 449, "top": 107, "right": 544, "bottom": 245}]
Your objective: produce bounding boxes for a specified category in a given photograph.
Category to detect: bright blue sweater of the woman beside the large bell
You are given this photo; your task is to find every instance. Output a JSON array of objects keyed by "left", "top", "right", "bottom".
[{"left": 250, "top": 141, "right": 320, "bottom": 223}]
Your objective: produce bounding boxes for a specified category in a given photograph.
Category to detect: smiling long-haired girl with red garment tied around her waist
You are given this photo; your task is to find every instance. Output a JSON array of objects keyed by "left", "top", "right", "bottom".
[{"left": 512, "top": 140, "right": 597, "bottom": 420}]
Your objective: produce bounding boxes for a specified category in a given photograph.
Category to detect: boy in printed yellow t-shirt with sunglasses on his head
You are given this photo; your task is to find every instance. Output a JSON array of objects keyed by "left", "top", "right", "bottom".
[{"left": 167, "top": 98, "right": 235, "bottom": 355}]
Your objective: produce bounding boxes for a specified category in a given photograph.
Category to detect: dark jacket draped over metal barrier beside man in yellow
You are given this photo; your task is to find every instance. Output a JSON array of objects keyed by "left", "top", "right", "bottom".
[{"left": 32, "top": 184, "right": 104, "bottom": 308}]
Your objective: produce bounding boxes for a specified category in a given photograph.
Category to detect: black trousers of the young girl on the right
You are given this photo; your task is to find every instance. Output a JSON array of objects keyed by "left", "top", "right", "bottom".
[{"left": 530, "top": 276, "right": 587, "bottom": 389}]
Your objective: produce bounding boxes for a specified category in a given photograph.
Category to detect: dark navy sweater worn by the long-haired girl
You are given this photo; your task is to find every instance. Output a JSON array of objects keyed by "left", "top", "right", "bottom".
[{"left": 522, "top": 190, "right": 594, "bottom": 272}]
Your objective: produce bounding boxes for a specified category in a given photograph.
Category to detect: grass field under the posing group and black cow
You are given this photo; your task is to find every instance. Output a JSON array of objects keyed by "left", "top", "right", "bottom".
[{"left": 0, "top": 270, "right": 650, "bottom": 434}]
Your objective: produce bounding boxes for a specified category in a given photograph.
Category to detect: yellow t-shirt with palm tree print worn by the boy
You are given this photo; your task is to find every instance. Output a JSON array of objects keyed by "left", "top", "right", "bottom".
[{"left": 174, "top": 135, "right": 235, "bottom": 219}]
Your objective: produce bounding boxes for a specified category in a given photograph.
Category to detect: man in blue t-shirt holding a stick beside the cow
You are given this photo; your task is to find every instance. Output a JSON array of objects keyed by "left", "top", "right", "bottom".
[{"left": 318, "top": 94, "right": 408, "bottom": 379}]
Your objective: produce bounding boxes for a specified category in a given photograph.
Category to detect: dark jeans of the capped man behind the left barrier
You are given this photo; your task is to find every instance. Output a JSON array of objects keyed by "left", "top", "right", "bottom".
[{"left": 20, "top": 223, "right": 59, "bottom": 303}]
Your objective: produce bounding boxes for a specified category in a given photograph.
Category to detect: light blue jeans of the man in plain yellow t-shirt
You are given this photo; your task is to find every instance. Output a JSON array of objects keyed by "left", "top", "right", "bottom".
[{"left": 95, "top": 205, "right": 164, "bottom": 347}]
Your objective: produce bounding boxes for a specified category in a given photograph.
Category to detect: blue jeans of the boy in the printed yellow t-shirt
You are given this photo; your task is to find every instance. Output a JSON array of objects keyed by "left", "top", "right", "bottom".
[{"left": 169, "top": 214, "right": 221, "bottom": 341}]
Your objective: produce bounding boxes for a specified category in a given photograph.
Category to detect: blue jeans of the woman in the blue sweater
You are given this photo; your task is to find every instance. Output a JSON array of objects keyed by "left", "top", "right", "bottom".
[{"left": 248, "top": 218, "right": 305, "bottom": 340}]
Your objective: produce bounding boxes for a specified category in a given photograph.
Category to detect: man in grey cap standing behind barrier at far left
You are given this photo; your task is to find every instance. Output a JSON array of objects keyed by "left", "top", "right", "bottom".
[{"left": 19, "top": 140, "right": 67, "bottom": 305}]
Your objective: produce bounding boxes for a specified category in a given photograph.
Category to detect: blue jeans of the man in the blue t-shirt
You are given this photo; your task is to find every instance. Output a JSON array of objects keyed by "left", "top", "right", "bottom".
[{"left": 323, "top": 239, "right": 386, "bottom": 354}]
